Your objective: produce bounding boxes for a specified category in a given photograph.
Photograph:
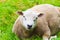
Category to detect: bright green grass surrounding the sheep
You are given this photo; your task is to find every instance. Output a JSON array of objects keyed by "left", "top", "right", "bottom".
[{"left": 0, "top": 0, "right": 60, "bottom": 40}]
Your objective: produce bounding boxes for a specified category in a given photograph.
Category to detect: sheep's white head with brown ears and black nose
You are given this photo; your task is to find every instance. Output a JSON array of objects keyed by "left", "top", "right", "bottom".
[{"left": 18, "top": 11, "right": 42, "bottom": 30}]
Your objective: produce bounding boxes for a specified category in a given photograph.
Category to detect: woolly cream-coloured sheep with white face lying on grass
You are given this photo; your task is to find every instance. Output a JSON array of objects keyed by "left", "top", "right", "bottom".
[{"left": 12, "top": 4, "right": 60, "bottom": 40}]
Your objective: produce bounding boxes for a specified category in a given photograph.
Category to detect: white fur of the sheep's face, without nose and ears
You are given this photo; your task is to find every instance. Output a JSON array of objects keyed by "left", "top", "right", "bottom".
[{"left": 21, "top": 9, "right": 39, "bottom": 30}]
